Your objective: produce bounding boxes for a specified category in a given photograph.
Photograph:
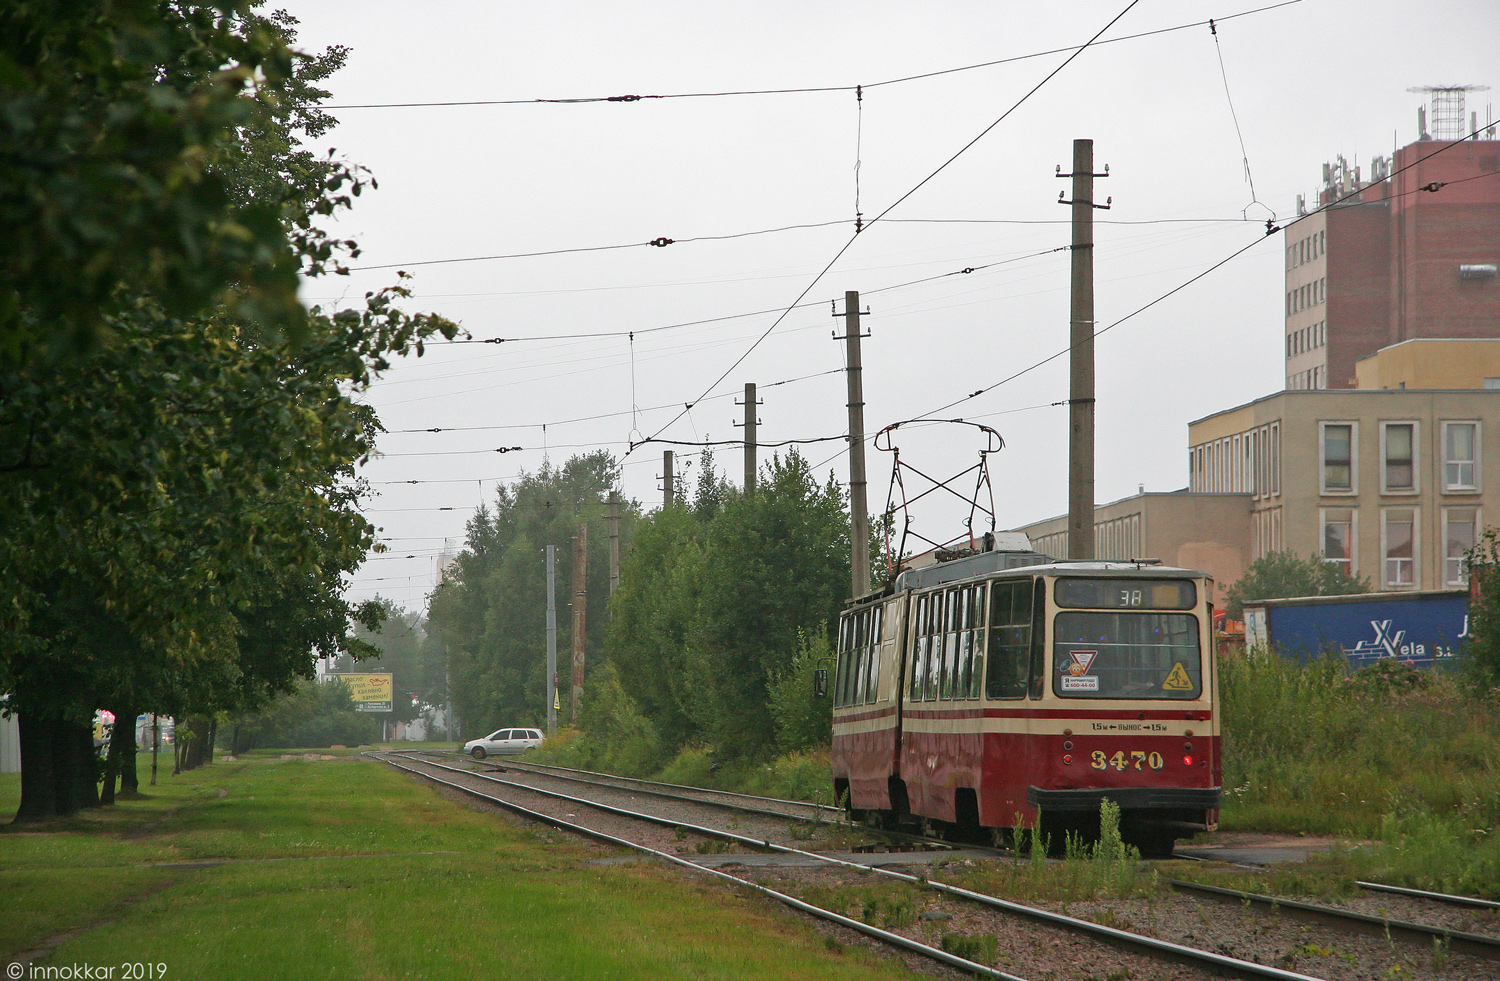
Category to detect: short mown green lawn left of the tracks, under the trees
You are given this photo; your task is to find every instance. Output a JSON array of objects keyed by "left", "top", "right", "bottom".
[{"left": 0, "top": 753, "right": 911, "bottom": 980}]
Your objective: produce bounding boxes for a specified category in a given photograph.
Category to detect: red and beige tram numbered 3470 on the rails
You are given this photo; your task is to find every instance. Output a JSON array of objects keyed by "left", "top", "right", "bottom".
[{"left": 833, "top": 551, "right": 1221, "bottom": 855}]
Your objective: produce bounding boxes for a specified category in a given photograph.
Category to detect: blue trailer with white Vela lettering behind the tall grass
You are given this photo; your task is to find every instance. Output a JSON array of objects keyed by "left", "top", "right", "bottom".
[{"left": 1245, "top": 590, "right": 1469, "bottom": 668}]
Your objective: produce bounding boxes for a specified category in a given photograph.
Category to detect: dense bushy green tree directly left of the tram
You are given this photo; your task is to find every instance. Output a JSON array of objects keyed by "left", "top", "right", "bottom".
[{"left": 609, "top": 452, "right": 849, "bottom": 758}]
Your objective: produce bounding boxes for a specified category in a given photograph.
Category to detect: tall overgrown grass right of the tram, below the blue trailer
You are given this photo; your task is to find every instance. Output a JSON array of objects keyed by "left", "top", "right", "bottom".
[{"left": 1221, "top": 657, "right": 1500, "bottom": 896}]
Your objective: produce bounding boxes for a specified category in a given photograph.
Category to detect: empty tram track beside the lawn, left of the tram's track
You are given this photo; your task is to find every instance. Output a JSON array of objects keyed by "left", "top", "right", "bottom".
[{"left": 381, "top": 755, "right": 1356, "bottom": 981}]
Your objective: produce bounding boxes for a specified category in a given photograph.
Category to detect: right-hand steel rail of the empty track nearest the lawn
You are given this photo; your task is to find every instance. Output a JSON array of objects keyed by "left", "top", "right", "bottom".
[{"left": 387, "top": 761, "right": 1320, "bottom": 981}]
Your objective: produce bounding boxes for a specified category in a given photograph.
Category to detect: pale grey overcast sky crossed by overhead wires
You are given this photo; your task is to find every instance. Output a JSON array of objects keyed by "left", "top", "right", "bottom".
[{"left": 284, "top": 0, "right": 1500, "bottom": 609}]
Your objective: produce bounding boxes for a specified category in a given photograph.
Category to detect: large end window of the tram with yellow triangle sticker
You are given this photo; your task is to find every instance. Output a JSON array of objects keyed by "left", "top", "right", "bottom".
[{"left": 1052, "top": 612, "right": 1203, "bottom": 701}]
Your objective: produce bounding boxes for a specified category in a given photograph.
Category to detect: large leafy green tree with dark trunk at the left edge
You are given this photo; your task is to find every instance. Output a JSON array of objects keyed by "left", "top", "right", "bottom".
[{"left": 0, "top": 3, "right": 456, "bottom": 821}]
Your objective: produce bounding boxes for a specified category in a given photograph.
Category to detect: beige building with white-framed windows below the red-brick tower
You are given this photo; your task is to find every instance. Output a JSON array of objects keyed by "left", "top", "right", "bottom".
[{"left": 1188, "top": 389, "right": 1500, "bottom": 590}]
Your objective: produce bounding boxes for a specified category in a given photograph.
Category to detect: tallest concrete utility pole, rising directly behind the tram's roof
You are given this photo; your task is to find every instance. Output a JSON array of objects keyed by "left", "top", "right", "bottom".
[{"left": 1058, "top": 140, "right": 1110, "bottom": 558}]
